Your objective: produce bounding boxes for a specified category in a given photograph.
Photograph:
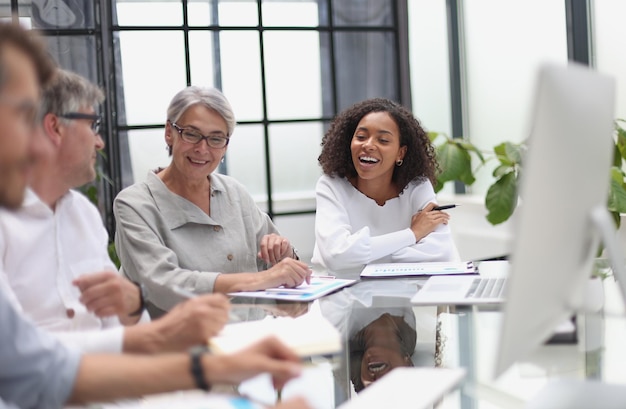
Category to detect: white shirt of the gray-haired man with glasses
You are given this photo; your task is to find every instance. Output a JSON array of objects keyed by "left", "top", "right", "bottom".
[{"left": 0, "top": 189, "right": 140, "bottom": 352}]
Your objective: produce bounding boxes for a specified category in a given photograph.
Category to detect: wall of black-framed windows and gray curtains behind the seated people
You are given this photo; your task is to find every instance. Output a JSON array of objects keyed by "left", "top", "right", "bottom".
[{"left": 0, "top": 0, "right": 626, "bottom": 262}]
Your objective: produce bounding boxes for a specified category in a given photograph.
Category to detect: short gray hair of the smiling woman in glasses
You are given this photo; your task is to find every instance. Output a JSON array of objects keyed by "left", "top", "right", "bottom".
[{"left": 167, "top": 86, "right": 236, "bottom": 136}]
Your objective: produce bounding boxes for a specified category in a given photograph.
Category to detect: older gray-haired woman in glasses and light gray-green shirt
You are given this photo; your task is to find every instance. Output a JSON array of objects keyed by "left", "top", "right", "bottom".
[{"left": 114, "top": 86, "right": 311, "bottom": 318}]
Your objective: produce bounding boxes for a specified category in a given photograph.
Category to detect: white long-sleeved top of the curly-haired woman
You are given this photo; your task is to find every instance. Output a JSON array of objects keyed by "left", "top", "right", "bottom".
[{"left": 311, "top": 175, "right": 459, "bottom": 271}]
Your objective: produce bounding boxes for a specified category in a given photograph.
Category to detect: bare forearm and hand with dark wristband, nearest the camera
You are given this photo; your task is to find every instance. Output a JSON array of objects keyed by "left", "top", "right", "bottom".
[{"left": 68, "top": 338, "right": 301, "bottom": 403}]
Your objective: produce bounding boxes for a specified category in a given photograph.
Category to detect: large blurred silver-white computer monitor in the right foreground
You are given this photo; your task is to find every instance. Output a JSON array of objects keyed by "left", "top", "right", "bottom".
[{"left": 495, "top": 63, "right": 623, "bottom": 376}]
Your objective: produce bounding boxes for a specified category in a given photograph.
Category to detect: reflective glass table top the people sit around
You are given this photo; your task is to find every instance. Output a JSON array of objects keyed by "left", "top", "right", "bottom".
[{"left": 232, "top": 278, "right": 626, "bottom": 408}]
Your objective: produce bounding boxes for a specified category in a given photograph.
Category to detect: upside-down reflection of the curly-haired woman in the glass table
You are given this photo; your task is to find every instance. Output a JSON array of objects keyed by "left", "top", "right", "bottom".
[{"left": 319, "top": 279, "right": 437, "bottom": 401}]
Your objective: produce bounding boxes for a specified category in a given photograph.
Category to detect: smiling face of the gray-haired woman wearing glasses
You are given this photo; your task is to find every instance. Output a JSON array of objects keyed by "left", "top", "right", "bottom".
[{"left": 165, "top": 105, "right": 228, "bottom": 179}]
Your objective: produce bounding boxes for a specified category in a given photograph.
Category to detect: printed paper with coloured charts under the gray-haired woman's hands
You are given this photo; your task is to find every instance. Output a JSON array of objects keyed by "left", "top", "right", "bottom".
[{"left": 229, "top": 276, "right": 356, "bottom": 301}]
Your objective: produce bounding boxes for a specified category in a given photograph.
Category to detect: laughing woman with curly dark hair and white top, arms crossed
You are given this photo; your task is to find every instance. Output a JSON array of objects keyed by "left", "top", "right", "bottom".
[{"left": 312, "top": 98, "right": 459, "bottom": 270}]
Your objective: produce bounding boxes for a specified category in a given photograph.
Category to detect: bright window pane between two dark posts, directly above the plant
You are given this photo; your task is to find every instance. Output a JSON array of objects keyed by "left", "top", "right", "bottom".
[{"left": 462, "top": 0, "right": 568, "bottom": 194}]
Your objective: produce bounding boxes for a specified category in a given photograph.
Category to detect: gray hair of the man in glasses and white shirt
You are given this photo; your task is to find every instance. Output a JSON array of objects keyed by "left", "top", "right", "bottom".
[{"left": 40, "top": 69, "right": 104, "bottom": 116}]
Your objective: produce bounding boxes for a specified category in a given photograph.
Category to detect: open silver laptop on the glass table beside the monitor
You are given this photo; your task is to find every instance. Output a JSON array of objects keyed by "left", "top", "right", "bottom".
[{"left": 411, "top": 260, "right": 509, "bottom": 305}]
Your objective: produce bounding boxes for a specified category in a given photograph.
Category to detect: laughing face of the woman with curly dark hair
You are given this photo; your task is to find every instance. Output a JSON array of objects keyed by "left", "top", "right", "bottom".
[{"left": 350, "top": 112, "right": 406, "bottom": 183}]
